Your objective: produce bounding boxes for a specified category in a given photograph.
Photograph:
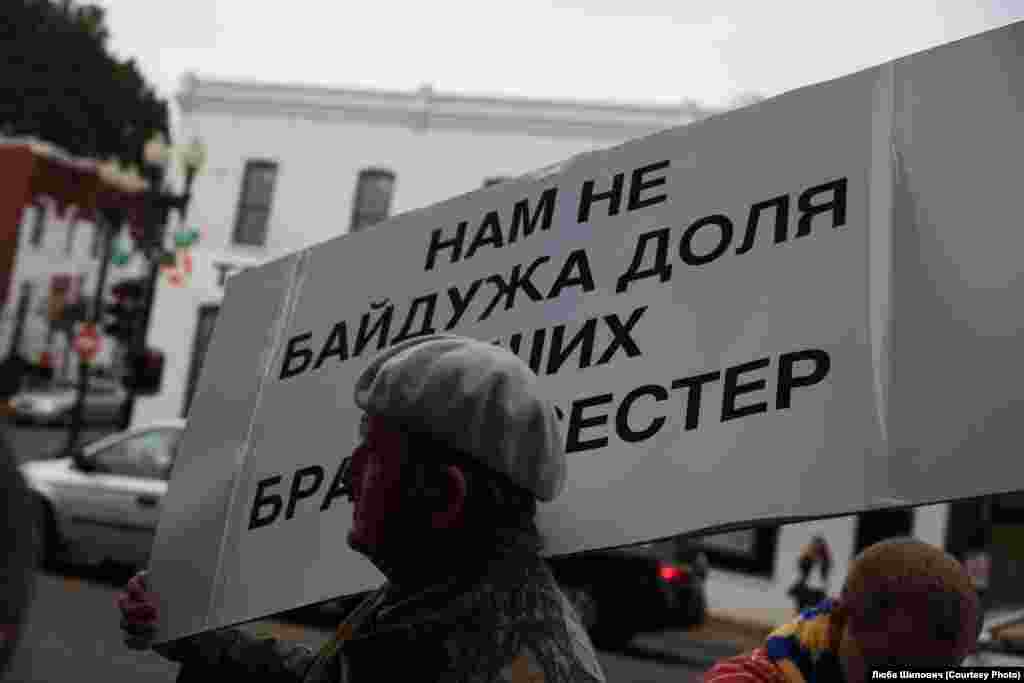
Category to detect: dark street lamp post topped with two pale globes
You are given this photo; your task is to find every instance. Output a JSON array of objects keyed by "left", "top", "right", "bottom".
[{"left": 121, "top": 134, "right": 206, "bottom": 429}]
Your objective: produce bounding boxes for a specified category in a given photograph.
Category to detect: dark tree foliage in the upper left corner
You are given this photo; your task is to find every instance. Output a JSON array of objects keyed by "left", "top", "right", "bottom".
[{"left": 0, "top": 0, "right": 170, "bottom": 166}]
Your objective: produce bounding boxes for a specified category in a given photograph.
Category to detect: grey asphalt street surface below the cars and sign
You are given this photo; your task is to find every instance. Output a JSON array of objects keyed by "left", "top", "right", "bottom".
[{"left": 6, "top": 569, "right": 700, "bottom": 683}]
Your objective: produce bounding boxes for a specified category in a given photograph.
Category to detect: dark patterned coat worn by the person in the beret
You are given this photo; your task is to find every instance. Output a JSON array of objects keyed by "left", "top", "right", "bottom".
[{"left": 161, "top": 554, "right": 604, "bottom": 683}]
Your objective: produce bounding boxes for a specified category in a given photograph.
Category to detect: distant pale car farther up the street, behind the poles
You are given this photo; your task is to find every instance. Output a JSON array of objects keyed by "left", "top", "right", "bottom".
[{"left": 10, "top": 379, "right": 127, "bottom": 424}]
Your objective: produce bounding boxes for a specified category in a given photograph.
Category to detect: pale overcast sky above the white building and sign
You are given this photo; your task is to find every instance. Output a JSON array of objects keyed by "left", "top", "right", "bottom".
[{"left": 94, "top": 0, "right": 1024, "bottom": 127}]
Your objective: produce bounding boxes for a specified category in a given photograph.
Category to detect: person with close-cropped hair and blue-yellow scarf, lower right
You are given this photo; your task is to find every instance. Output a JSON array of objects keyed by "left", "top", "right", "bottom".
[{"left": 703, "top": 539, "right": 981, "bottom": 683}]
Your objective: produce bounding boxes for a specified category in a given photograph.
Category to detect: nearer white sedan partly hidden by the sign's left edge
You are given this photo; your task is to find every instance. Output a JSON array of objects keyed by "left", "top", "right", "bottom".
[{"left": 19, "top": 420, "right": 185, "bottom": 567}]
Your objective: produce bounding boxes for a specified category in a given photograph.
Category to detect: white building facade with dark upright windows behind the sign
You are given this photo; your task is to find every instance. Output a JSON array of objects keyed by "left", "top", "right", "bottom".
[{"left": 134, "top": 76, "right": 949, "bottom": 614}]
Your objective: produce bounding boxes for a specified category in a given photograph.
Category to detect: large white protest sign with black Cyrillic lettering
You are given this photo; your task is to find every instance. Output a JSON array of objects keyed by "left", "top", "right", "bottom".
[{"left": 153, "top": 20, "right": 1024, "bottom": 638}]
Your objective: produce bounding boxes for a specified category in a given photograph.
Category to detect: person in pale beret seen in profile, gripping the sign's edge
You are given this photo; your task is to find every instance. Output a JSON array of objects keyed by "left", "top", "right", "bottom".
[{"left": 118, "top": 335, "right": 604, "bottom": 683}]
